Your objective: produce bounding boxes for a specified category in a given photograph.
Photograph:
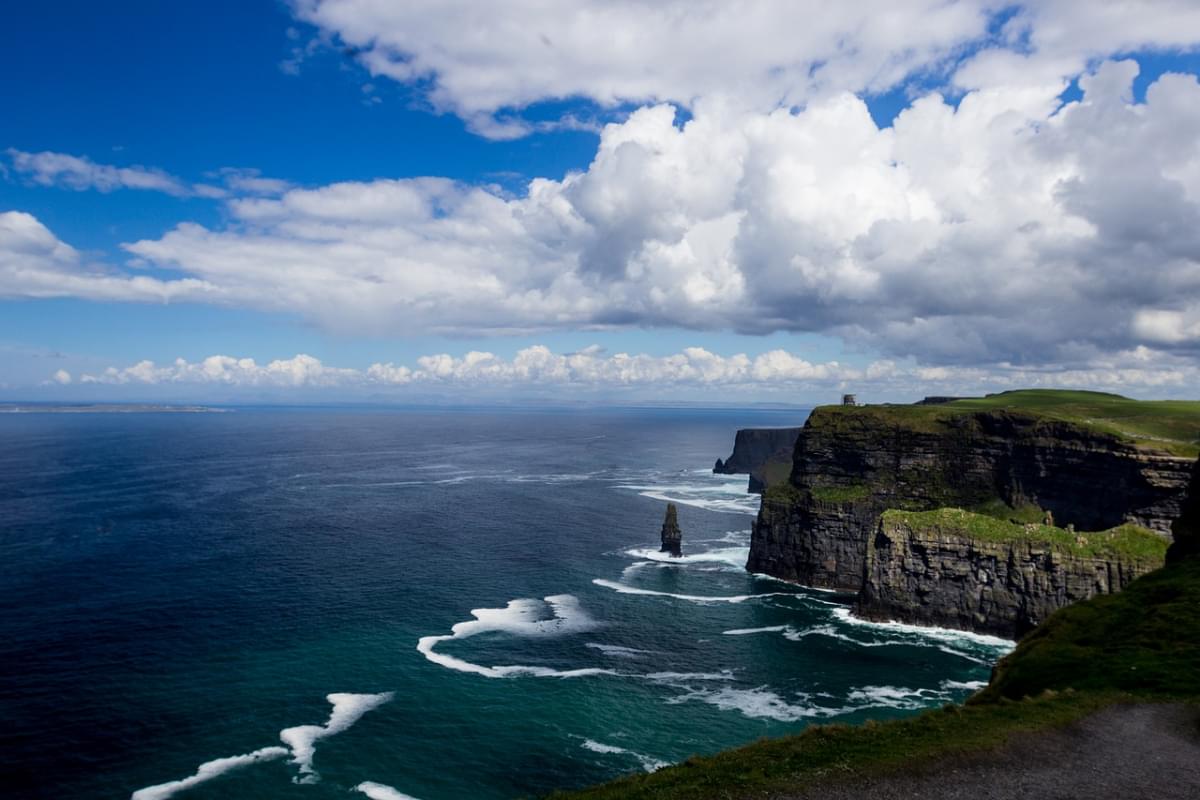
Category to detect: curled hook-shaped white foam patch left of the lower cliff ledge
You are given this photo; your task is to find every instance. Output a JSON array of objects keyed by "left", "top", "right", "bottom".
[{"left": 416, "top": 595, "right": 617, "bottom": 678}]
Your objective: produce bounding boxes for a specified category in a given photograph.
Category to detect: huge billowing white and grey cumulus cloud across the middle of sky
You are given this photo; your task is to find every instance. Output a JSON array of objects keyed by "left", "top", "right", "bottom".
[{"left": 39, "top": 61, "right": 1180, "bottom": 365}]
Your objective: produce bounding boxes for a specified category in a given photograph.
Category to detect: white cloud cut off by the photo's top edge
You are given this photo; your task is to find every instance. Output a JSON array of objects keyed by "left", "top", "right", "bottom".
[{"left": 292, "top": 0, "right": 1200, "bottom": 138}]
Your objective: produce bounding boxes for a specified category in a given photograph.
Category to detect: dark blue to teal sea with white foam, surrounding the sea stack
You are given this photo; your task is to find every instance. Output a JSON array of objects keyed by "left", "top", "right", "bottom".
[{"left": 0, "top": 409, "right": 1006, "bottom": 800}]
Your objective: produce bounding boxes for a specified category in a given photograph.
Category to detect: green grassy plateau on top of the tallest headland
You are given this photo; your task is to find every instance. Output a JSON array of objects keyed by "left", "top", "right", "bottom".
[{"left": 814, "top": 389, "right": 1200, "bottom": 458}]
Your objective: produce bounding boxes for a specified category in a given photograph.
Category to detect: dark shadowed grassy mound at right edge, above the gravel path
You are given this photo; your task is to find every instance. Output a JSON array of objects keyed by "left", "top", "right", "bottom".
[{"left": 973, "top": 558, "right": 1200, "bottom": 702}]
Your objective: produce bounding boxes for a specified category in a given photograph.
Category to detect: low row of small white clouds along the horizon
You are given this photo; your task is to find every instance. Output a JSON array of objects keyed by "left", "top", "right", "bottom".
[{"left": 72, "top": 345, "right": 1200, "bottom": 399}]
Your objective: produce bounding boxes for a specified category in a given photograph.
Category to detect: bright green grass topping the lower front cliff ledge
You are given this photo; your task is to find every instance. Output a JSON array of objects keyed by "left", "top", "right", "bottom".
[{"left": 881, "top": 509, "right": 1168, "bottom": 564}]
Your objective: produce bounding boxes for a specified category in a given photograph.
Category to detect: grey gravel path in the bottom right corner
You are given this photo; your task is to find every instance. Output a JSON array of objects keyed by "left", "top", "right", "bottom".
[{"left": 774, "top": 704, "right": 1200, "bottom": 800}]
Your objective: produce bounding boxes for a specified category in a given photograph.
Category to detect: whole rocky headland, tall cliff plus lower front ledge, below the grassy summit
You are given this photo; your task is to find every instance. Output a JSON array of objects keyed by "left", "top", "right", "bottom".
[{"left": 746, "top": 393, "right": 1200, "bottom": 636}]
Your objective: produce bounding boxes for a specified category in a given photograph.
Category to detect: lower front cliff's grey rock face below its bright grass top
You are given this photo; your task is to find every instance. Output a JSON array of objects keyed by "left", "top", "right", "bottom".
[{"left": 856, "top": 515, "right": 1165, "bottom": 639}]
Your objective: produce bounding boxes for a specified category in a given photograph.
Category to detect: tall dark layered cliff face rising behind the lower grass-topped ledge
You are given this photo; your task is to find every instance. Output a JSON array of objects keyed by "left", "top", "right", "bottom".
[{"left": 746, "top": 405, "right": 1192, "bottom": 590}]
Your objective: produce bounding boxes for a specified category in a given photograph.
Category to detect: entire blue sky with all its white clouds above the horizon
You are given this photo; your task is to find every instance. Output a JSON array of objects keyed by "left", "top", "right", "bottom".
[{"left": 0, "top": 0, "right": 1200, "bottom": 402}]
